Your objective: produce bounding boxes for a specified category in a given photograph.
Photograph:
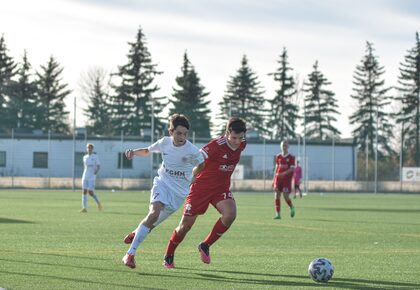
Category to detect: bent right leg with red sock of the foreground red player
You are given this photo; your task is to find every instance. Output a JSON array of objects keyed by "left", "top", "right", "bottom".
[{"left": 198, "top": 197, "right": 236, "bottom": 264}]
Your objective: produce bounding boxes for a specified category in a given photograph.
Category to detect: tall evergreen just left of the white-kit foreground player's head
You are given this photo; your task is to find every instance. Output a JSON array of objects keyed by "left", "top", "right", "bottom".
[{"left": 112, "top": 28, "right": 163, "bottom": 136}]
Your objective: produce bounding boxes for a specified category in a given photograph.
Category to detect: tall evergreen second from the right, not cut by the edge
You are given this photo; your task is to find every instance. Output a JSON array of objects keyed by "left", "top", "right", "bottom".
[{"left": 350, "top": 42, "right": 393, "bottom": 156}]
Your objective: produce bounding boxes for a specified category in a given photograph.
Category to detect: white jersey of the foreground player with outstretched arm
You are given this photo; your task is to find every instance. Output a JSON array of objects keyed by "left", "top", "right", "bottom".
[{"left": 147, "top": 136, "right": 204, "bottom": 197}]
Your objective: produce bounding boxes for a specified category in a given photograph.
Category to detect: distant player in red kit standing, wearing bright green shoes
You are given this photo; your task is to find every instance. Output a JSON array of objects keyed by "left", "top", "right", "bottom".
[{"left": 273, "top": 140, "right": 295, "bottom": 219}]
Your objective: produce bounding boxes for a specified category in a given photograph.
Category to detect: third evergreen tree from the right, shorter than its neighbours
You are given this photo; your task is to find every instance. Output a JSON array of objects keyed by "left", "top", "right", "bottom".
[{"left": 303, "top": 61, "right": 340, "bottom": 140}]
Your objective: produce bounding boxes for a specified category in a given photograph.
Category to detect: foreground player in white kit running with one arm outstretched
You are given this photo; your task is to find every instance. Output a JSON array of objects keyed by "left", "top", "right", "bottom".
[{"left": 122, "top": 114, "right": 204, "bottom": 268}]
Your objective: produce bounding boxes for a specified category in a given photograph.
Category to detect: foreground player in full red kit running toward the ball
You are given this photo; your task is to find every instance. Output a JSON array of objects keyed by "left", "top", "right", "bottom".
[{"left": 163, "top": 118, "right": 246, "bottom": 268}]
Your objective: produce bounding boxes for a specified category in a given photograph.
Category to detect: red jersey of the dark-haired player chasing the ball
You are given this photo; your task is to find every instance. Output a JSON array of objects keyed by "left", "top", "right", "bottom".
[{"left": 191, "top": 136, "right": 246, "bottom": 192}]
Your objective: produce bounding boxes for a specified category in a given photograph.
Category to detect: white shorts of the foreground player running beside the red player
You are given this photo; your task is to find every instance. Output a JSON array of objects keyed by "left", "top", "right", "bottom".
[{"left": 150, "top": 178, "right": 187, "bottom": 226}]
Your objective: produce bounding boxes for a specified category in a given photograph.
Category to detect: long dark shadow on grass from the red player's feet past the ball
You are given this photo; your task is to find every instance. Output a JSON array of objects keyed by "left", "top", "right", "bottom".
[{"left": 177, "top": 268, "right": 420, "bottom": 290}]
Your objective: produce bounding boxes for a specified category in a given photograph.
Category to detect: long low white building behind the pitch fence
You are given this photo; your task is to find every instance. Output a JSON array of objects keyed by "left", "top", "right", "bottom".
[{"left": 0, "top": 134, "right": 357, "bottom": 180}]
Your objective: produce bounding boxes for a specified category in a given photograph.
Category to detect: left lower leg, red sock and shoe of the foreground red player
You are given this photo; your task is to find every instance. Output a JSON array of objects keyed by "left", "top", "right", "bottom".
[{"left": 163, "top": 214, "right": 197, "bottom": 269}]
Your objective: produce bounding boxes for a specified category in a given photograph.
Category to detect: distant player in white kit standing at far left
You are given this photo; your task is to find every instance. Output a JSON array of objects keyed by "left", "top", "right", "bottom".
[{"left": 80, "top": 143, "right": 102, "bottom": 212}]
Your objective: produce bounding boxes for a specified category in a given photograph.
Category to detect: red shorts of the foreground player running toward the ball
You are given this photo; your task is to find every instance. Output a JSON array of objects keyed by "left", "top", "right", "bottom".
[{"left": 184, "top": 190, "right": 235, "bottom": 216}]
